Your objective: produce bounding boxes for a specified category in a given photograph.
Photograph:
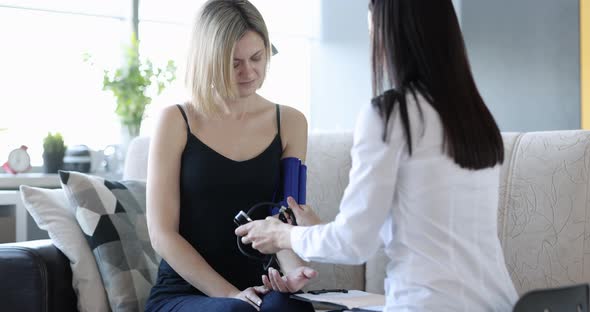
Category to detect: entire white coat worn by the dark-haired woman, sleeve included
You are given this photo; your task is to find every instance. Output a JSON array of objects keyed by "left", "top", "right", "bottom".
[{"left": 291, "top": 96, "right": 518, "bottom": 312}]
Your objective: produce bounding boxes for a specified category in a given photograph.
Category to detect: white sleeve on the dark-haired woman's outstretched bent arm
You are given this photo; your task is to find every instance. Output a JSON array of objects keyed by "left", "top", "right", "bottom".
[{"left": 291, "top": 105, "right": 406, "bottom": 264}]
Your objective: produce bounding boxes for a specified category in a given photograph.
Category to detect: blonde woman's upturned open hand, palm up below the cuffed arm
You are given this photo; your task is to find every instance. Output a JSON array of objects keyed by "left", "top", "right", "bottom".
[{"left": 262, "top": 266, "right": 318, "bottom": 293}]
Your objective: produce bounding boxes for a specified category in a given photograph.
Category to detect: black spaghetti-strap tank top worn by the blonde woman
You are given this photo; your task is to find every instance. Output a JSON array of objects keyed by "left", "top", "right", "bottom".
[{"left": 150, "top": 105, "right": 282, "bottom": 301}]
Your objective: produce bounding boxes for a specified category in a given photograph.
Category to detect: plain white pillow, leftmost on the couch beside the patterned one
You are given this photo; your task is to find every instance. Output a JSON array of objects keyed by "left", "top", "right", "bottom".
[{"left": 20, "top": 185, "right": 110, "bottom": 312}]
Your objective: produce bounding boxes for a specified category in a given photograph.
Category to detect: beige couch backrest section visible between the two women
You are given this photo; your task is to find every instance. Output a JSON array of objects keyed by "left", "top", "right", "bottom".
[{"left": 306, "top": 133, "right": 365, "bottom": 290}]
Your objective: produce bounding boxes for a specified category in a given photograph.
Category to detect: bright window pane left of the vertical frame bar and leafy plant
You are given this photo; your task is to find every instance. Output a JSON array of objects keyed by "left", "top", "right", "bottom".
[{"left": 0, "top": 1, "right": 129, "bottom": 166}]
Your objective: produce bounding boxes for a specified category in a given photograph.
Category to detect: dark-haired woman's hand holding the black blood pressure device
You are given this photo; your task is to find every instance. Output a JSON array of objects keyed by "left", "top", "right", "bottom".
[{"left": 235, "top": 217, "right": 293, "bottom": 254}]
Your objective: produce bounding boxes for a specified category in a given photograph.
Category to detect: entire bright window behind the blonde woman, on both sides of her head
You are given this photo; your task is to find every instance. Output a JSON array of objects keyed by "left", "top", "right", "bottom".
[{"left": 0, "top": 0, "right": 317, "bottom": 166}]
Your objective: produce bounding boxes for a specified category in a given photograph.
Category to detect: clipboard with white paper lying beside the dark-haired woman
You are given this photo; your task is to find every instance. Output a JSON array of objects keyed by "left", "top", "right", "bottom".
[{"left": 291, "top": 290, "right": 385, "bottom": 311}]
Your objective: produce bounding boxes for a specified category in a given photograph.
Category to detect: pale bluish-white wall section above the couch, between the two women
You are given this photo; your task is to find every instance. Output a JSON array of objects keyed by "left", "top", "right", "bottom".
[{"left": 309, "top": 0, "right": 462, "bottom": 131}]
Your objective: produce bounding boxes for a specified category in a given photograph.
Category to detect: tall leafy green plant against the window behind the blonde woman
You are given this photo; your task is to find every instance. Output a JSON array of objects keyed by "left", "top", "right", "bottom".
[{"left": 103, "top": 35, "right": 176, "bottom": 137}]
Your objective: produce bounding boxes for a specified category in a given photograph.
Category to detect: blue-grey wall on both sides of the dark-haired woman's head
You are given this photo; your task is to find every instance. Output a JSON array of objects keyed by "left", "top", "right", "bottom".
[{"left": 310, "top": 0, "right": 580, "bottom": 131}]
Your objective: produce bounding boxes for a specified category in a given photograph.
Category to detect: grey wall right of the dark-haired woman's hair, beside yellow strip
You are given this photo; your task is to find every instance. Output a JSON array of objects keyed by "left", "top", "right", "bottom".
[{"left": 461, "top": 0, "right": 580, "bottom": 131}]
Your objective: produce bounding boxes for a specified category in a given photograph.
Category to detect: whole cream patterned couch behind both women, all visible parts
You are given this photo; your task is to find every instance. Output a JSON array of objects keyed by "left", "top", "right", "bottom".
[{"left": 124, "top": 130, "right": 590, "bottom": 294}]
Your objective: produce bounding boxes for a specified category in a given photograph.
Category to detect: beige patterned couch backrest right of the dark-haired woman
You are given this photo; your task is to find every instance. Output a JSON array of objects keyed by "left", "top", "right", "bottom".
[{"left": 499, "top": 131, "right": 590, "bottom": 294}]
